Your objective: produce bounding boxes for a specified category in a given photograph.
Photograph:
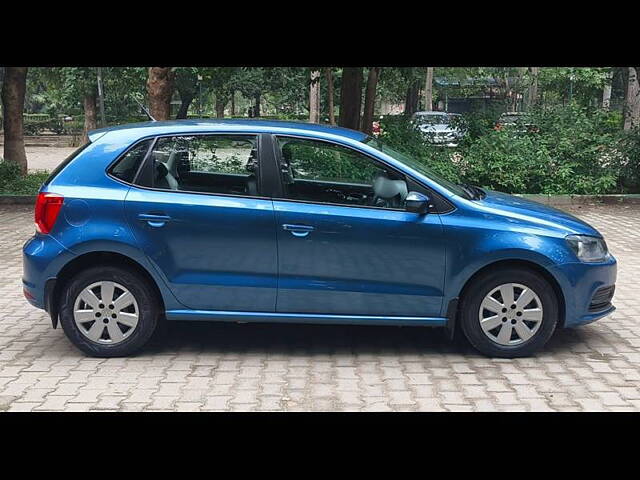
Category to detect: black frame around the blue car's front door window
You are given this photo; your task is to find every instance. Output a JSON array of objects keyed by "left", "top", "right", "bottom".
[{"left": 272, "top": 133, "right": 420, "bottom": 212}]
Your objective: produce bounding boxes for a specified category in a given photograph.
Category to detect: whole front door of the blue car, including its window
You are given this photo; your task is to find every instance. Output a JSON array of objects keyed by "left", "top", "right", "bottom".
[{"left": 274, "top": 136, "right": 445, "bottom": 317}]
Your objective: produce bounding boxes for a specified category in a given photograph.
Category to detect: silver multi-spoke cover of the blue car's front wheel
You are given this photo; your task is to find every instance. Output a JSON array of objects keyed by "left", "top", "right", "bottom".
[{"left": 478, "top": 283, "right": 543, "bottom": 346}]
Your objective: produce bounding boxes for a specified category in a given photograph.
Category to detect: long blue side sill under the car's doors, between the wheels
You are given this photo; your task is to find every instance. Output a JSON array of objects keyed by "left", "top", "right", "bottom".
[{"left": 166, "top": 310, "right": 447, "bottom": 327}]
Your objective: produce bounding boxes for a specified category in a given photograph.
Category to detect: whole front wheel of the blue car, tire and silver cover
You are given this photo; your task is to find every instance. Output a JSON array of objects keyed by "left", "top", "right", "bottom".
[{"left": 460, "top": 268, "right": 558, "bottom": 358}]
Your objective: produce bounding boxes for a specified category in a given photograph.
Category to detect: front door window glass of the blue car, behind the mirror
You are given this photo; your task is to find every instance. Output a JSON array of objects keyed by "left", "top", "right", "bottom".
[{"left": 278, "top": 137, "right": 407, "bottom": 209}]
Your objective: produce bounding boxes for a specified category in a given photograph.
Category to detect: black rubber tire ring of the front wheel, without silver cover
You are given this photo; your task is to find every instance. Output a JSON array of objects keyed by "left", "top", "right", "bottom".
[{"left": 460, "top": 269, "right": 559, "bottom": 358}]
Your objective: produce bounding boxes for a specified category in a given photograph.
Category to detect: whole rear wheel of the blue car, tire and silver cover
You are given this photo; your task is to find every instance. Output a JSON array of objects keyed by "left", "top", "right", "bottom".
[{"left": 60, "top": 266, "right": 161, "bottom": 358}]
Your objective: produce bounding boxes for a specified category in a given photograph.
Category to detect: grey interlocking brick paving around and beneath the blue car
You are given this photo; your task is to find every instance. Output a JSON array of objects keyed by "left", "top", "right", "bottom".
[{"left": 0, "top": 206, "right": 640, "bottom": 411}]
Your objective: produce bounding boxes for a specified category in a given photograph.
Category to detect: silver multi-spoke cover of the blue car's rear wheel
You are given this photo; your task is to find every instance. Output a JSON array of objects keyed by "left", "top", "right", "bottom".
[{"left": 73, "top": 281, "right": 139, "bottom": 345}]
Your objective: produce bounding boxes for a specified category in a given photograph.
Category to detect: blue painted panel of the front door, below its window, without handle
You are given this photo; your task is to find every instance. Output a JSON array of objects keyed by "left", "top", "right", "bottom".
[{"left": 274, "top": 200, "right": 445, "bottom": 316}]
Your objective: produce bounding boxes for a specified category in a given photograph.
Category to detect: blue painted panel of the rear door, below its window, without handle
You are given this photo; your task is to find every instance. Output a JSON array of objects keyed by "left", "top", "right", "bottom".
[{"left": 125, "top": 187, "right": 278, "bottom": 312}]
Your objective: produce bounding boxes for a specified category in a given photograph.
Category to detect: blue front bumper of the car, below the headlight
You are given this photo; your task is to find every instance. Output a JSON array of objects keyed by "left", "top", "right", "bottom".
[{"left": 550, "top": 256, "right": 618, "bottom": 327}]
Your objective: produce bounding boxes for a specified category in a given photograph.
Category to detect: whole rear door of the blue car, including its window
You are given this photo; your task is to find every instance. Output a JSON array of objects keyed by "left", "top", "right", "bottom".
[{"left": 125, "top": 134, "right": 277, "bottom": 312}]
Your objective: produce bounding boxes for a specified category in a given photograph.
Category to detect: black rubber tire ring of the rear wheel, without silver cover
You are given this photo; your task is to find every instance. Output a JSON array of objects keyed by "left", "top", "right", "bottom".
[{"left": 60, "top": 266, "right": 159, "bottom": 357}]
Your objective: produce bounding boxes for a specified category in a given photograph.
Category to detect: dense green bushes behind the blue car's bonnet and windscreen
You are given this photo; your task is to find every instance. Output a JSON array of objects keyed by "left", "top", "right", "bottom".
[{"left": 382, "top": 104, "right": 640, "bottom": 194}]
